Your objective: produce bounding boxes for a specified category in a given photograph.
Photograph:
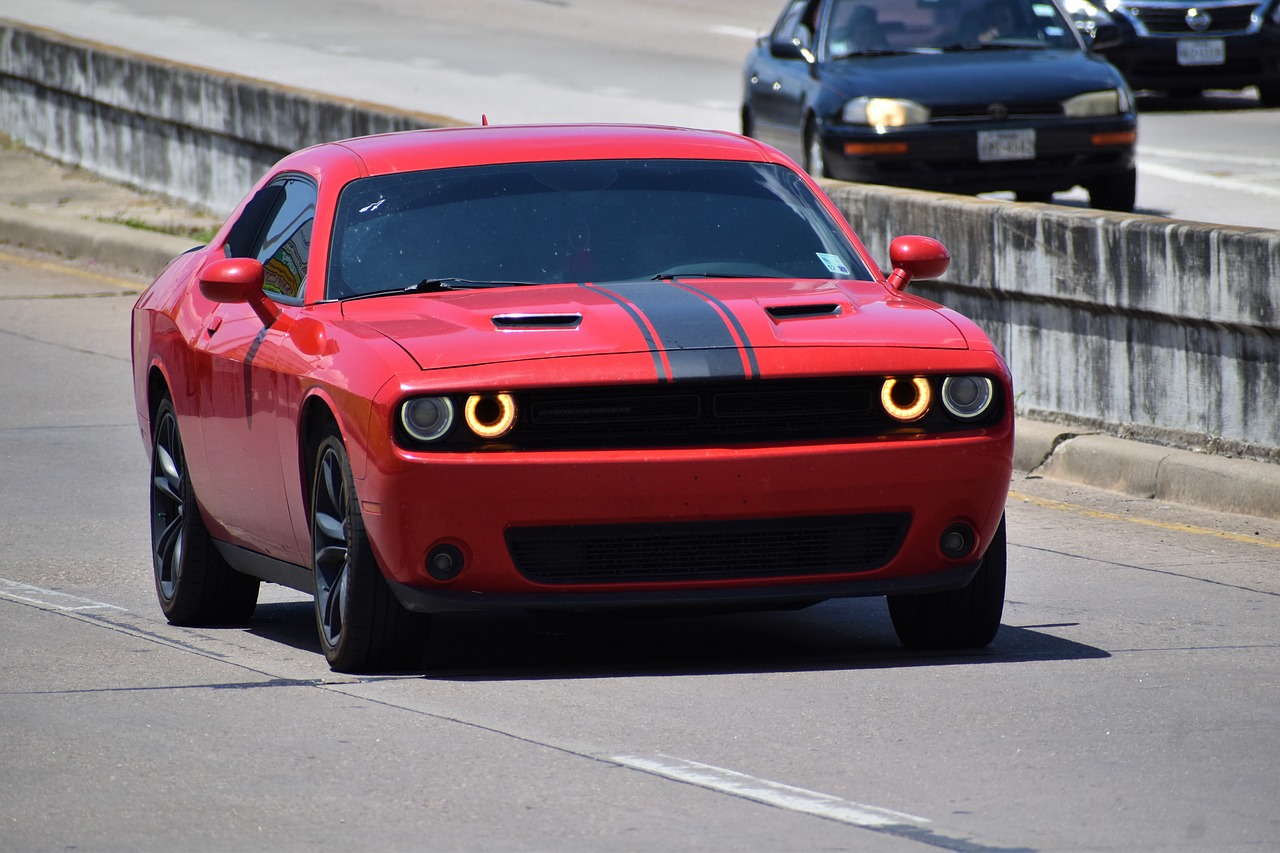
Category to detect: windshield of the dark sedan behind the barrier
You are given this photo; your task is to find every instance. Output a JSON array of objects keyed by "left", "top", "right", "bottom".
[{"left": 823, "top": 0, "right": 1079, "bottom": 59}]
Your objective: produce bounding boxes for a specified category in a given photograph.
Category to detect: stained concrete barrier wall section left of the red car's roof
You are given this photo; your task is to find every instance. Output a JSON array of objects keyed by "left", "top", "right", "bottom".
[{"left": 0, "top": 20, "right": 460, "bottom": 213}]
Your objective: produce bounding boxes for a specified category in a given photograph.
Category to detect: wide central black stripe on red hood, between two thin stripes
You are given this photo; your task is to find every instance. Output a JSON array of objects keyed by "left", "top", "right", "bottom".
[{"left": 608, "top": 282, "right": 746, "bottom": 380}]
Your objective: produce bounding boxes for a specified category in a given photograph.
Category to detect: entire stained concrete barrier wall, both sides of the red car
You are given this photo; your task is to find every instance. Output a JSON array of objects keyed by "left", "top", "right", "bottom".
[{"left": 0, "top": 22, "right": 1280, "bottom": 462}]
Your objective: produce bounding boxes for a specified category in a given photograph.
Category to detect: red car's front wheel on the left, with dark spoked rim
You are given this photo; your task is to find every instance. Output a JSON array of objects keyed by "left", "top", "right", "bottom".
[{"left": 310, "top": 427, "right": 430, "bottom": 672}]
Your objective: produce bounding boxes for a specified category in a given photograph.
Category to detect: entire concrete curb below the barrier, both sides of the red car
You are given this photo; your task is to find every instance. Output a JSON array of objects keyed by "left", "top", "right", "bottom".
[{"left": 0, "top": 192, "right": 1280, "bottom": 521}]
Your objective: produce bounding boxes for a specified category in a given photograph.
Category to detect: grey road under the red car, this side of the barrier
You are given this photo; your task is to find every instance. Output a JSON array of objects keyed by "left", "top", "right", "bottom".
[{"left": 0, "top": 254, "right": 1280, "bottom": 852}]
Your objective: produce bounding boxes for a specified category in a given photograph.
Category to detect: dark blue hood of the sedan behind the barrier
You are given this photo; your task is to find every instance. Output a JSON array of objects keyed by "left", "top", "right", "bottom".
[{"left": 820, "top": 49, "right": 1123, "bottom": 106}]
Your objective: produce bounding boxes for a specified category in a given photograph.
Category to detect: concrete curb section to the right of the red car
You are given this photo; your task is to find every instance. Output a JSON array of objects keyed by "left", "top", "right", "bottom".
[{"left": 1014, "top": 420, "right": 1280, "bottom": 521}]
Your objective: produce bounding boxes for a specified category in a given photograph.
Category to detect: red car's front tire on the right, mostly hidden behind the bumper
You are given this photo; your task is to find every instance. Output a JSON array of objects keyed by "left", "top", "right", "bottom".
[{"left": 888, "top": 517, "right": 1009, "bottom": 649}]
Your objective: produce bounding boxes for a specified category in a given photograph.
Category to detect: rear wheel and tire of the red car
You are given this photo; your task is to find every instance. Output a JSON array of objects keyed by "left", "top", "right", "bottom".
[{"left": 151, "top": 396, "right": 260, "bottom": 625}]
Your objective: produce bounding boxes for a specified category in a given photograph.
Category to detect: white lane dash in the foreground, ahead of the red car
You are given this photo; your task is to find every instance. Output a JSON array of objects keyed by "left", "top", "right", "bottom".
[{"left": 609, "top": 754, "right": 931, "bottom": 829}]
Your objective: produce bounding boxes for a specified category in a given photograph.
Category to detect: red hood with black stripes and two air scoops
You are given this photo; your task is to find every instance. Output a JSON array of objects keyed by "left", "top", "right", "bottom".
[{"left": 343, "top": 279, "right": 968, "bottom": 378}]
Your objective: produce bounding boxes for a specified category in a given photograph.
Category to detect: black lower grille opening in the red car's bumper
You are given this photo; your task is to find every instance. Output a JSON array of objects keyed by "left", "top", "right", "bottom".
[{"left": 507, "top": 512, "right": 910, "bottom": 584}]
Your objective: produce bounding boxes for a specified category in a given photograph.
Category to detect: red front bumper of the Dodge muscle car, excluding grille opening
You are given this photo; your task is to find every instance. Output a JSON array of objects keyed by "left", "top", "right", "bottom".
[{"left": 357, "top": 419, "right": 1012, "bottom": 611}]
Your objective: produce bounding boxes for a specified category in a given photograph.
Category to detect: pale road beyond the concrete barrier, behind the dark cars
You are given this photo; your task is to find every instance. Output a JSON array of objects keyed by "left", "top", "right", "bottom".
[{"left": 0, "top": 0, "right": 1280, "bottom": 228}]
